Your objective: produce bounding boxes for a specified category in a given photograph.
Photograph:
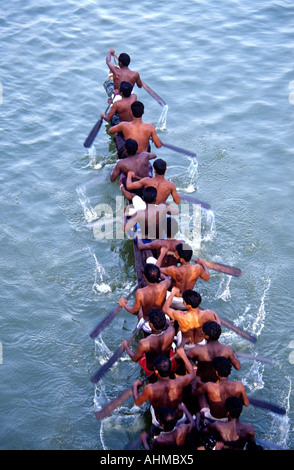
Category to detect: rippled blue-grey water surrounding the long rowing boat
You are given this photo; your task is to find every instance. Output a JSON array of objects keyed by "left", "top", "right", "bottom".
[{"left": 0, "top": 0, "right": 294, "bottom": 450}]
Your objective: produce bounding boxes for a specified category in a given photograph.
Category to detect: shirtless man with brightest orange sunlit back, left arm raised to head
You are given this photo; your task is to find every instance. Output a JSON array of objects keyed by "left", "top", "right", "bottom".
[{"left": 162, "top": 287, "right": 221, "bottom": 347}]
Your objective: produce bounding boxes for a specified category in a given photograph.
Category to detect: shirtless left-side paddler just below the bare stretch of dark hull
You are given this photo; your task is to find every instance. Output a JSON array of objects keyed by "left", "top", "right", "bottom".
[{"left": 119, "top": 263, "right": 171, "bottom": 320}]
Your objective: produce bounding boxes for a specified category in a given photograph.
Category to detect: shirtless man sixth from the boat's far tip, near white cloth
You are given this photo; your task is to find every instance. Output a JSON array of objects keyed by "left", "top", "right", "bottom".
[{"left": 125, "top": 186, "right": 179, "bottom": 241}]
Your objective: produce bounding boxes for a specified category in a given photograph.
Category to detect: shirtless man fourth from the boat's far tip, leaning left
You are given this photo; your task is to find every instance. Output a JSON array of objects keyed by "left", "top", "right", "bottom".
[{"left": 110, "top": 139, "right": 156, "bottom": 185}]
